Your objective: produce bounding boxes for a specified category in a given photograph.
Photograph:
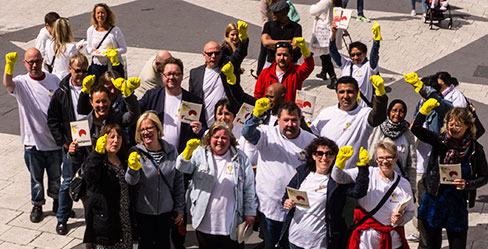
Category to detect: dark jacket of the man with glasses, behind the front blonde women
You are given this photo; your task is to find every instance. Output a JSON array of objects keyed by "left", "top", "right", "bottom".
[{"left": 139, "top": 87, "right": 207, "bottom": 153}]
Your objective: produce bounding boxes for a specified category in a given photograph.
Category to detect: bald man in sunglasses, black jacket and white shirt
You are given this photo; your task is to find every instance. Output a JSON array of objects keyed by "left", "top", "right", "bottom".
[{"left": 189, "top": 41, "right": 256, "bottom": 127}]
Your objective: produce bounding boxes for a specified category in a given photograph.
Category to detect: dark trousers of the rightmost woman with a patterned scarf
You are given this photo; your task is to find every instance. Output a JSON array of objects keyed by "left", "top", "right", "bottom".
[{"left": 421, "top": 220, "right": 468, "bottom": 249}]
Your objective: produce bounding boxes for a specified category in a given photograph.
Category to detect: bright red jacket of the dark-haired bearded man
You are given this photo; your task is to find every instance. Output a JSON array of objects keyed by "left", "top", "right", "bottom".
[{"left": 254, "top": 56, "right": 315, "bottom": 102}]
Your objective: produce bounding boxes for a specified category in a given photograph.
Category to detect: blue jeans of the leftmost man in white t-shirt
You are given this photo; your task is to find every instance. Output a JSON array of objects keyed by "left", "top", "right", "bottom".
[{"left": 24, "top": 146, "right": 62, "bottom": 205}]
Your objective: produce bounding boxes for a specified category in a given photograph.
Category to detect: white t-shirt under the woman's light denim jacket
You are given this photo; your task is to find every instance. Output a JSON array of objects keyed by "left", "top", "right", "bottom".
[{"left": 197, "top": 150, "right": 236, "bottom": 235}]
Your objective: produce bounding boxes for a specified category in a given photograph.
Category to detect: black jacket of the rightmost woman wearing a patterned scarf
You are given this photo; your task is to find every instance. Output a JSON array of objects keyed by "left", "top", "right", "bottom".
[{"left": 412, "top": 113, "right": 488, "bottom": 208}]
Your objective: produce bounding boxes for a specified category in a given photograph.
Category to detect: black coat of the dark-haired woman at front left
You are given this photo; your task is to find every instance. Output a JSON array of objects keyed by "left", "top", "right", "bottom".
[{"left": 83, "top": 151, "right": 129, "bottom": 245}]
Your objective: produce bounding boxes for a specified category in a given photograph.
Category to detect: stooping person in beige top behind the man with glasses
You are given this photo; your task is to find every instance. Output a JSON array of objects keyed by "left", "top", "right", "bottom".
[{"left": 134, "top": 50, "right": 173, "bottom": 99}]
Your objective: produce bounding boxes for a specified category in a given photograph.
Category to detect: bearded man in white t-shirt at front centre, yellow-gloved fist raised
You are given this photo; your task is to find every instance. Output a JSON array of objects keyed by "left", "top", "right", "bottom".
[{"left": 242, "top": 98, "right": 315, "bottom": 249}]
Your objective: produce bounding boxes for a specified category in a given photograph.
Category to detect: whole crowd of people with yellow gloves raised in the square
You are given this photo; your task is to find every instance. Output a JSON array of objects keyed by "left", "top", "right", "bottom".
[{"left": 3, "top": 0, "right": 488, "bottom": 249}]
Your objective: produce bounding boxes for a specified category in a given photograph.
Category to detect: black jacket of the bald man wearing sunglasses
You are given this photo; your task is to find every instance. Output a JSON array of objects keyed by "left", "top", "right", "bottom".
[{"left": 189, "top": 39, "right": 256, "bottom": 110}]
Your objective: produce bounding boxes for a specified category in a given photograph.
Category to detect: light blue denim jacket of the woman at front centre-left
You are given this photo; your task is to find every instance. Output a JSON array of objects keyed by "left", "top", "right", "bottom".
[{"left": 176, "top": 146, "right": 258, "bottom": 240}]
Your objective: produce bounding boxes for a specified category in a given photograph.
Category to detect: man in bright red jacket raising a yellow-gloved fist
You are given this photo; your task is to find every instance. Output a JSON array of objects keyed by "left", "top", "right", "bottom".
[{"left": 254, "top": 37, "right": 315, "bottom": 101}]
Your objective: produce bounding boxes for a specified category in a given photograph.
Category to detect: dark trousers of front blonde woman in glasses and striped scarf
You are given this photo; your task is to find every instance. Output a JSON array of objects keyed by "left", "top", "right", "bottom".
[{"left": 136, "top": 212, "right": 172, "bottom": 249}]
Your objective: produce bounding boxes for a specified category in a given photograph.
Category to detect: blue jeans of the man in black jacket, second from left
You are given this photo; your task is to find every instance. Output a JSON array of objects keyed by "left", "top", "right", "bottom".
[{"left": 56, "top": 147, "right": 80, "bottom": 222}]
